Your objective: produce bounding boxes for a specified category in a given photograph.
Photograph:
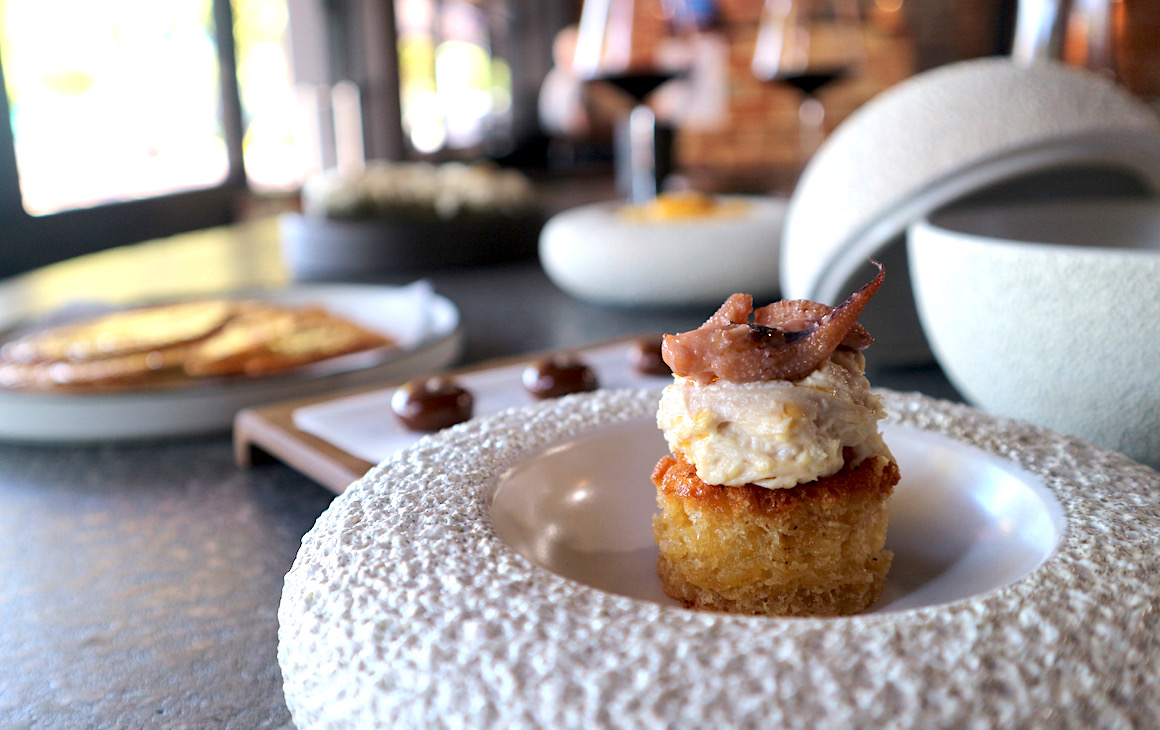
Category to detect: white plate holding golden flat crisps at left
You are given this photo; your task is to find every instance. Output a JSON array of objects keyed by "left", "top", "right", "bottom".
[{"left": 0, "top": 282, "right": 462, "bottom": 442}]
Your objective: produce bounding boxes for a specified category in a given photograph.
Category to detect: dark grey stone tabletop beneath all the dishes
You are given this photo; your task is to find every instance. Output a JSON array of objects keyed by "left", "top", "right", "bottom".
[{"left": 0, "top": 218, "right": 956, "bottom": 730}]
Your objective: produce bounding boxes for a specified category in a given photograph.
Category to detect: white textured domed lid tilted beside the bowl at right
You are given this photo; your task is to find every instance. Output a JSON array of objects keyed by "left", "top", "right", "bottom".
[{"left": 781, "top": 58, "right": 1160, "bottom": 364}]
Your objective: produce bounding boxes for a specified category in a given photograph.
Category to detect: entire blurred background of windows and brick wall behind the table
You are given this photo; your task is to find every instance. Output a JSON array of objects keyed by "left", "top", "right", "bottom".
[{"left": 0, "top": 0, "right": 1160, "bottom": 276}]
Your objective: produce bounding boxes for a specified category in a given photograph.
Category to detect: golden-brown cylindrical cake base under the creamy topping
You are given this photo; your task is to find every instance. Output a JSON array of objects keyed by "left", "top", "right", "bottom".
[{"left": 653, "top": 456, "right": 899, "bottom": 616}]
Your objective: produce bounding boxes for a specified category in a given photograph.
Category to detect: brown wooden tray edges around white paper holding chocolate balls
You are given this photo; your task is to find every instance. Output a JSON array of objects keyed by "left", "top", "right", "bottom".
[{"left": 233, "top": 338, "right": 663, "bottom": 494}]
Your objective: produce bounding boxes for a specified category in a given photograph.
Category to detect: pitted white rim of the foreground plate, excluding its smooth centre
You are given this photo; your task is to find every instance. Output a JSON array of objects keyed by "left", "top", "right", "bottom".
[{"left": 278, "top": 391, "right": 1160, "bottom": 730}]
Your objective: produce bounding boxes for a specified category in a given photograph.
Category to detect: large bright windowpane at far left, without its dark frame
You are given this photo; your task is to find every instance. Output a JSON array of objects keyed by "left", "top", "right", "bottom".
[{"left": 2, "top": 0, "right": 230, "bottom": 216}]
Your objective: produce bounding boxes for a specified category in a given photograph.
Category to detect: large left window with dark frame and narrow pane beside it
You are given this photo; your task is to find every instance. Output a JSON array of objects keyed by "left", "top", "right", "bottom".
[{"left": 0, "top": 0, "right": 305, "bottom": 275}]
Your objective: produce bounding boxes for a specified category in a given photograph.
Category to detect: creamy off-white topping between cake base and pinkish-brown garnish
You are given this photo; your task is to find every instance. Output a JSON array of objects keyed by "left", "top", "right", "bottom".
[{"left": 657, "top": 350, "right": 892, "bottom": 489}]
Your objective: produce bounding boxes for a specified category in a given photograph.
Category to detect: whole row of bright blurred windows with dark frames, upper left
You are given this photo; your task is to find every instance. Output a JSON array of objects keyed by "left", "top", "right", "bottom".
[{"left": 0, "top": 0, "right": 578, "bottom": 277}]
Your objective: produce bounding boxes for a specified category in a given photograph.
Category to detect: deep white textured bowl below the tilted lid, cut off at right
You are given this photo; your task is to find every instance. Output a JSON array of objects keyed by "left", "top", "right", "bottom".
[{"left": 908, "top": 200, "right": 1160, "bottom": 465}]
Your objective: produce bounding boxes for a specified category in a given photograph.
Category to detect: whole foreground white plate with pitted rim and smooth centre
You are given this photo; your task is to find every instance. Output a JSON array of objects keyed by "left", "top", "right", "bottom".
[{"left": 278, "top": 390, "right": 1160, "bottom": 729}]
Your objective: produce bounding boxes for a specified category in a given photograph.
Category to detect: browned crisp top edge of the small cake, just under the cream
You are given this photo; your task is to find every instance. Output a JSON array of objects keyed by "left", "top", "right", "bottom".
[{"left": 652, "top": 454, "right": 899, "bottom": 516}]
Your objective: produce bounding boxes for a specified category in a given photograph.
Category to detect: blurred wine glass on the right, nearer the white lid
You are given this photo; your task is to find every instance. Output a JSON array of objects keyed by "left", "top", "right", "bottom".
[{"left": 753, "top": 0, "right": 865, "bottom": 178}]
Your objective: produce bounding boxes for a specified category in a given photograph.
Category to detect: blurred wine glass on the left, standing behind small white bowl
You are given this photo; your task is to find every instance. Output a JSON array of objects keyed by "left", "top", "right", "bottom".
[{"left": 573, "top": 0, "right": 695, "bottom": 203}]
